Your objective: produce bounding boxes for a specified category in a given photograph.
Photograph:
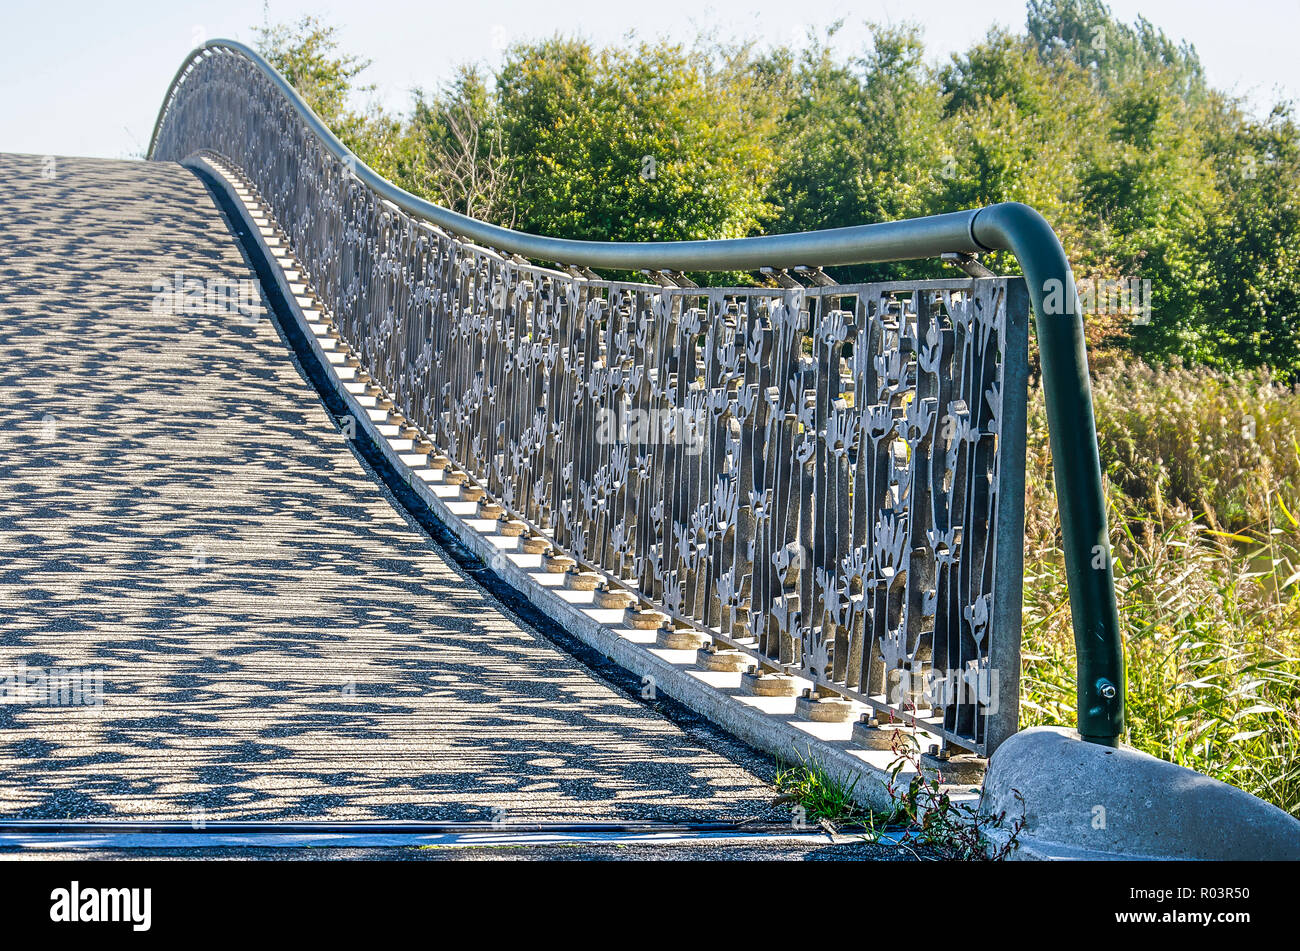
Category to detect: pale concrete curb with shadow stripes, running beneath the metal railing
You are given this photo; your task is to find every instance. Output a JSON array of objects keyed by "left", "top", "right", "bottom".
[{"left": 183, "top": 155, "right": 979, "bottom": 811}]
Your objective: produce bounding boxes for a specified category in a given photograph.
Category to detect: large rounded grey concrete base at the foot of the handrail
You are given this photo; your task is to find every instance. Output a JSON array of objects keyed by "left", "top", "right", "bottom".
[{"left": 982, "top": 726, "right": 1300, "bottom": 861}]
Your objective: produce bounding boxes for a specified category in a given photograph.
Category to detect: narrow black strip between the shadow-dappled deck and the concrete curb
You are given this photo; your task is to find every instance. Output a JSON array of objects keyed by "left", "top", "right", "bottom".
[{"left": 185, "top": 165, "right": 776, "bottom": 782}]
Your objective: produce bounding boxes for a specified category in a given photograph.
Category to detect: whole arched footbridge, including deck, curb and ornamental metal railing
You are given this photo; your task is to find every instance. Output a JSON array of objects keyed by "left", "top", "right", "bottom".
[{"left": 0, "top": 40, "right": 1125, "bottom": 847}]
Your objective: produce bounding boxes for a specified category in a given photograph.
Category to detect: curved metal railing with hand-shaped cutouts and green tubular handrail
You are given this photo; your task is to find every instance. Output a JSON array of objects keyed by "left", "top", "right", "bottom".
[{"left": 150, "top": 40, "right": 1123, "bottom": 754}]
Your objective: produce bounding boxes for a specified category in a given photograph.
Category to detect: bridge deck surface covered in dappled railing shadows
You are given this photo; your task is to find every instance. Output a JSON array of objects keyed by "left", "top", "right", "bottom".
[{"left": 0, "top": 156, "right": 772, "bottom": 818}]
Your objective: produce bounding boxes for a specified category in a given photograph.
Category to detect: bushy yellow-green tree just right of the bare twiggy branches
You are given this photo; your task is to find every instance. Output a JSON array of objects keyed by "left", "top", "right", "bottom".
[{"left": 497, "top": 38, "right": 772, "bottom": 262}]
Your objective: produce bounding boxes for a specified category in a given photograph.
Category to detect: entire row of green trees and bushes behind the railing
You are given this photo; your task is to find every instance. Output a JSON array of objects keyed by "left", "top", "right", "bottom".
[{"left": 250, "top": 0, "right": 1300, "bottom": 381}]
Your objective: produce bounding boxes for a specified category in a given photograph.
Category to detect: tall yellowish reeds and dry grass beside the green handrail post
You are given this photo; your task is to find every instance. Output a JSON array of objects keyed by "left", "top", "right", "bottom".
[{"left": 1022, "top": 362, "right": 1300, "bottom": 815}]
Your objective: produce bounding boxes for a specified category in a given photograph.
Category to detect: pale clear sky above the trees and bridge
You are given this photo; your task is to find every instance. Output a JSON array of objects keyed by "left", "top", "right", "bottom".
[{"left": 0, "top": 0, "right": 1300, "bottom": 157}]
